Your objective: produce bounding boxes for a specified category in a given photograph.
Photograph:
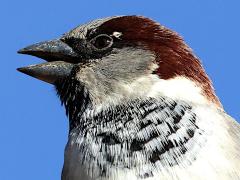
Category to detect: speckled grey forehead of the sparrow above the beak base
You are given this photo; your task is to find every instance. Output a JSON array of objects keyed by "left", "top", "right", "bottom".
[{"left": 63, "top": 16, "right": 121, "bottom": 39}]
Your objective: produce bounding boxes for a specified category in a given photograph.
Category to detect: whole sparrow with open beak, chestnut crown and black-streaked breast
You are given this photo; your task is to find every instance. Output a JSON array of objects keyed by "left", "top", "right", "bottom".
[{"left": 18, "top": 15, "right": 240, "bottom": 180}]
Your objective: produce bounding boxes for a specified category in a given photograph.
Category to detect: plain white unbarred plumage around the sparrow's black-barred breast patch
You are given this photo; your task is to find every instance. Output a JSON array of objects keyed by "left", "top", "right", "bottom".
[{"left": 63, "top": 76, "right": 240, "bottom": 180}]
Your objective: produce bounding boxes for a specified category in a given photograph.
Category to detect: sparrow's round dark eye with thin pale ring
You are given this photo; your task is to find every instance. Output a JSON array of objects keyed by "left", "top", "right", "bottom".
[{"left": 90, "top": 34, "right": 113, "bottom": 50}]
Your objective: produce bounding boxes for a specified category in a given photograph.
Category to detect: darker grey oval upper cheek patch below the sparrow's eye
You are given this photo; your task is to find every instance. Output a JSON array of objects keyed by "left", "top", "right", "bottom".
[{"left": 94, "top": 48, "right": 155, "bottom": 82}]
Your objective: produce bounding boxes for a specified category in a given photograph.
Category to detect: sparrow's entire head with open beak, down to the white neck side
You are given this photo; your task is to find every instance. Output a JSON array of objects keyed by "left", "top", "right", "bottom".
[{"left": 18, "top": 16, "right": 221, "bottom": 107}]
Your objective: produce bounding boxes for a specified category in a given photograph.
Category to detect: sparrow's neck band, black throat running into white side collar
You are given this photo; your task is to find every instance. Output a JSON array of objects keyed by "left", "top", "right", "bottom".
[{"left": 56, "top": 75, "right": 221, "bottom": 131}]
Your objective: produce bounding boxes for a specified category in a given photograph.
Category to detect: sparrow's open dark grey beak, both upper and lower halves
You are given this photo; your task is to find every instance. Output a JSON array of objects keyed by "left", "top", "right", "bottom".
[{"left": 17, "top": 39, "right": 78, "bottom": 84}]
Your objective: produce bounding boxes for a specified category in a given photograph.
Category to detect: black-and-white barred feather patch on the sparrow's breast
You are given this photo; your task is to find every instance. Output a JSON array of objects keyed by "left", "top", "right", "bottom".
[{"left": 63, "top": 97, "right": 206, "bottom": 179}]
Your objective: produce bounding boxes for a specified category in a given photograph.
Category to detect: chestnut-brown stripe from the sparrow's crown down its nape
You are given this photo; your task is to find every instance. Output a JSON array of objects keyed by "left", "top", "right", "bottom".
[{"left": 100, "top": 16, "right": 221, "bottom": 107}]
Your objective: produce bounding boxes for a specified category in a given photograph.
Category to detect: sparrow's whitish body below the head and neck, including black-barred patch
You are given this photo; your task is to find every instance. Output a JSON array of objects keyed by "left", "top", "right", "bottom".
[{"left": 58, "top": 72, "right": 240, "bottom": 180}]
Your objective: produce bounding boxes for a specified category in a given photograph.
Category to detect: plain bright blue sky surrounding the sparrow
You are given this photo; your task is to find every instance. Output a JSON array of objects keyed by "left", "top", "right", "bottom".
[{"left": 0, "top": 0, "right": 240, "bottom": 180}]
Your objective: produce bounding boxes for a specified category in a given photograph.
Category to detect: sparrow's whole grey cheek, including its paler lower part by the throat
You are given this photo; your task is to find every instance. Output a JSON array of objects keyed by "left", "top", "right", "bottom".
[{"left": 77, "top": 48, "right": 155, "bottom": 101}]
